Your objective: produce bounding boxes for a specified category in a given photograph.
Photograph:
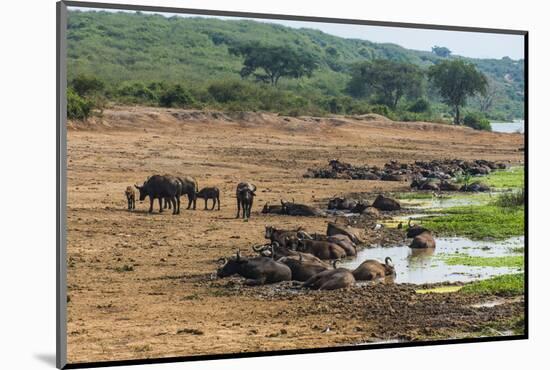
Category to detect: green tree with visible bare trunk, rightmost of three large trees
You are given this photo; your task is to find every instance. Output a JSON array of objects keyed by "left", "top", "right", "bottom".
[{"left": 428, "top": 60, "right": 487, "bottom": 124}]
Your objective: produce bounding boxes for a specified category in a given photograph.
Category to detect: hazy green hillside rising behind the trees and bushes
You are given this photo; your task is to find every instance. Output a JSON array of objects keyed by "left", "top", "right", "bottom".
[{"left": 67, "top": 10, "right": 524, "bottom": 120}]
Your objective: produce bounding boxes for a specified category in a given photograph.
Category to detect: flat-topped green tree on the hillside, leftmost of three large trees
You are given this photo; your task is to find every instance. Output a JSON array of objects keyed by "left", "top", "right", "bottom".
[{"left": 229, "top": 42, "right": 317, "bottom": 85}]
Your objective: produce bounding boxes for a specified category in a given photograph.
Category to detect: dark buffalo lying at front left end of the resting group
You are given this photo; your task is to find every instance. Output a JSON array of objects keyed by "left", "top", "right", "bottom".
[{"left": 217, "top": 251, "right": 292, "bottom": 285}]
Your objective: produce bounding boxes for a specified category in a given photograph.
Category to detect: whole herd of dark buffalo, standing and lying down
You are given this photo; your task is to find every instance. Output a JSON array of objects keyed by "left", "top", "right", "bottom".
[{"left": 124, "top": 160, "right": 488, "bottom": 290}]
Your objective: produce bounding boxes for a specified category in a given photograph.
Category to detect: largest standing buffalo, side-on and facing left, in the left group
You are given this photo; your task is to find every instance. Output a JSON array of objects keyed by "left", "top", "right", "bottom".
[{"left": 134, "top": 175, "right": 180, "bottom": 215}]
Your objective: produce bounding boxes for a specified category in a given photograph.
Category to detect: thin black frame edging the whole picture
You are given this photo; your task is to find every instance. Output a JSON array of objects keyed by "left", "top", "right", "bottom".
[{"left": 56, "top": 1, "right": 529, "bottom": 369}]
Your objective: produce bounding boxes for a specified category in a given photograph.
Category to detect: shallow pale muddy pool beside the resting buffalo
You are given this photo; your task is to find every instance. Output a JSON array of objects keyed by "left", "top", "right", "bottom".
[{"left": 342, "top": 237, "right": 524, "bottom": 284}]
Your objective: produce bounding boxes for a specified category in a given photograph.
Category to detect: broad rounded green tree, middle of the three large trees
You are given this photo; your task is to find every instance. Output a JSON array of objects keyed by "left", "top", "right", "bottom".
[{"left": 348, "top": 59, "right": 423, "bottom": 109}]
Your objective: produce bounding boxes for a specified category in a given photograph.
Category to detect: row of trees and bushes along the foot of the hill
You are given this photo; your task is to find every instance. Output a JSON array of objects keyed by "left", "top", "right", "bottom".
[{"left": 68, "top": 42, "right": 490, "bottom": 129}]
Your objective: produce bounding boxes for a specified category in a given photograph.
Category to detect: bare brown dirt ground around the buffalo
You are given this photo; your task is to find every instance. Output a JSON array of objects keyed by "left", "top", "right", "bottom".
[{"left": 67, "top": 107, "right": 523, "bottom": 363}]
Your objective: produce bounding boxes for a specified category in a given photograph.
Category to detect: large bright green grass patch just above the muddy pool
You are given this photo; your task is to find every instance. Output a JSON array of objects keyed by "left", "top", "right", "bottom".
[{"left": 422, "top": 205, "right": 525, "bottom": 239}]
